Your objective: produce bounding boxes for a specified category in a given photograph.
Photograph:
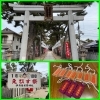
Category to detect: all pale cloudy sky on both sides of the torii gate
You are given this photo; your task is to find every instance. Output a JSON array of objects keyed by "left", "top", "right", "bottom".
[{"left": 2, "top": 2, "right": 98, "bottom": 40}]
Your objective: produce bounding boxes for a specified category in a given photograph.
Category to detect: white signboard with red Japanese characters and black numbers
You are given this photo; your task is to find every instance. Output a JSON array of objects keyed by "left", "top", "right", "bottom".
[{"left": 8, "top": 72, "right": 41, "bottom": 88}]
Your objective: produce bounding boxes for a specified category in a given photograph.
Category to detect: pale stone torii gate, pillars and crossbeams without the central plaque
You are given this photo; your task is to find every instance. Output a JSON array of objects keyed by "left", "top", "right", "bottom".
[{"left": 9, "top": 4, "right": 86, "bottom": 60}]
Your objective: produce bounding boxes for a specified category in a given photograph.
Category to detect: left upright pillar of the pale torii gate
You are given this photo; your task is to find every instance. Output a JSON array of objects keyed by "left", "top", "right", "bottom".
[{"left": 20, "top": 10, "right": 29, "bottom": 60}]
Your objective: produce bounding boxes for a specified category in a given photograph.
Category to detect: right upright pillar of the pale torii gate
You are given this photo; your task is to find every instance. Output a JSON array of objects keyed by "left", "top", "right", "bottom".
[{"left": 68, "top": 10, "right": 79, "bottom": 60}]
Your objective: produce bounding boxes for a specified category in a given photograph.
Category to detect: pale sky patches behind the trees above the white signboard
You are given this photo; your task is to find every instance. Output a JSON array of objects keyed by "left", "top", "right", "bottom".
[{"left": 2, "top": 62, "right": 49, "bottom": 77}]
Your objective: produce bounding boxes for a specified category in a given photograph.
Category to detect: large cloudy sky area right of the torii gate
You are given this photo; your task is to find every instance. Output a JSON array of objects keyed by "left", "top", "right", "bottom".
[{"left": 75, "top": 3, "right": 99, "bottom": 40}]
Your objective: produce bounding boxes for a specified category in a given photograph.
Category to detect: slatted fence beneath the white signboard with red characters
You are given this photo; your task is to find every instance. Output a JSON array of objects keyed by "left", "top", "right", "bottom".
[{"left": 2, "top": 87, "right": 26, "bottom": 99}]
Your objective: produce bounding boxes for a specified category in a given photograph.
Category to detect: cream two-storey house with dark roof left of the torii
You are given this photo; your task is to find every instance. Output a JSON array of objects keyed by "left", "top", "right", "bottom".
[{"left": 2, "top": 28, "right": 21, "bottom": 51}]
